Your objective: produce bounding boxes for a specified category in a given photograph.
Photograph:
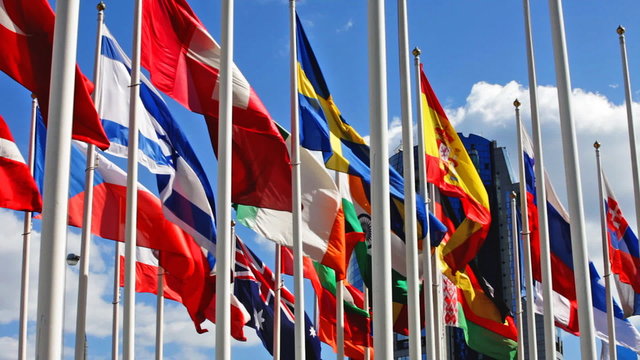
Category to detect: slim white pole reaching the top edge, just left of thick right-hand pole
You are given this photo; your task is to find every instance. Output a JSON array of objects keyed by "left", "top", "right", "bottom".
[{"left": 520, "top": 0, "right": 556, "bottom": 360}]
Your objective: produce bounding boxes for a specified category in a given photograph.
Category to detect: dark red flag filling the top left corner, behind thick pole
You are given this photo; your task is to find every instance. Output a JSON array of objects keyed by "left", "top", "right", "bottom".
[{"left": 0, "top": 0, "right": 109, "bottom": 149}]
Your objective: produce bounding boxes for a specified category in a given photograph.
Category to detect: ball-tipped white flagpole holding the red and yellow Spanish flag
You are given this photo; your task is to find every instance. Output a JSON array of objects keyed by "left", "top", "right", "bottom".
[{"left": 413, "top": 48, "right": 439, "bottom": 359}]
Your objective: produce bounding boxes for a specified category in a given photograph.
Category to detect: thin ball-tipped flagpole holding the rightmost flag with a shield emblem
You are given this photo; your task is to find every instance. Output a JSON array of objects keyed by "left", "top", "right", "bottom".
[{"left": 593, "top": 141, "right": 618, "bottom": 360}]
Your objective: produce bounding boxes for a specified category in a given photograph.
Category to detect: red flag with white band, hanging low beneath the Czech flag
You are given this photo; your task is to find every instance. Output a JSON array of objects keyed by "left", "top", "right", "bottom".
[{"left": 118, "top": 242, "right": 249, "bottom": 341}]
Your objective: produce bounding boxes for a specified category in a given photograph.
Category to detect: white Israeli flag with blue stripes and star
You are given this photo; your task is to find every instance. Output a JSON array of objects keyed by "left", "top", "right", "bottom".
[{"left": 97, "top": 25, "right": 216, "bottom": 266}]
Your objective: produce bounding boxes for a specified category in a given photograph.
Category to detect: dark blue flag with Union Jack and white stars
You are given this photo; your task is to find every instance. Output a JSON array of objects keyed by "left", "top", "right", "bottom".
[{"left": 234, "top": 237, "right": 320, "bottom": 360}]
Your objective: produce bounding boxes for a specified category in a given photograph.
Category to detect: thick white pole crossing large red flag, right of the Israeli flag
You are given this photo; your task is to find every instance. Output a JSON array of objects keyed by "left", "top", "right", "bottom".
[{"left": 216, "top": 0, "right": 234, "bottom": 360}]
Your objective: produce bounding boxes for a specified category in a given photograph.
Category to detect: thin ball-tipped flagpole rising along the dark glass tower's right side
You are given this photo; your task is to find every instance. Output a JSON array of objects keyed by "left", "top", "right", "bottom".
[{"left": 513, "top": 99, "right": 536, "bottom": 359}]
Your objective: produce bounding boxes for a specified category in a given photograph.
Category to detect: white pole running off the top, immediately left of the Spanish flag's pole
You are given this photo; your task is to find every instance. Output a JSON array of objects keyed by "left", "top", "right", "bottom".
[{"left": 398, "top": 0, "right": 422, "bottom": 359}]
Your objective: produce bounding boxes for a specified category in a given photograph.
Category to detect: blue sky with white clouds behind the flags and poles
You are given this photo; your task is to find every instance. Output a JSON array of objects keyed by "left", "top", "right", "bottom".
[{"left": 0, "top": 0, "right": 640, "bottom": 359}]
